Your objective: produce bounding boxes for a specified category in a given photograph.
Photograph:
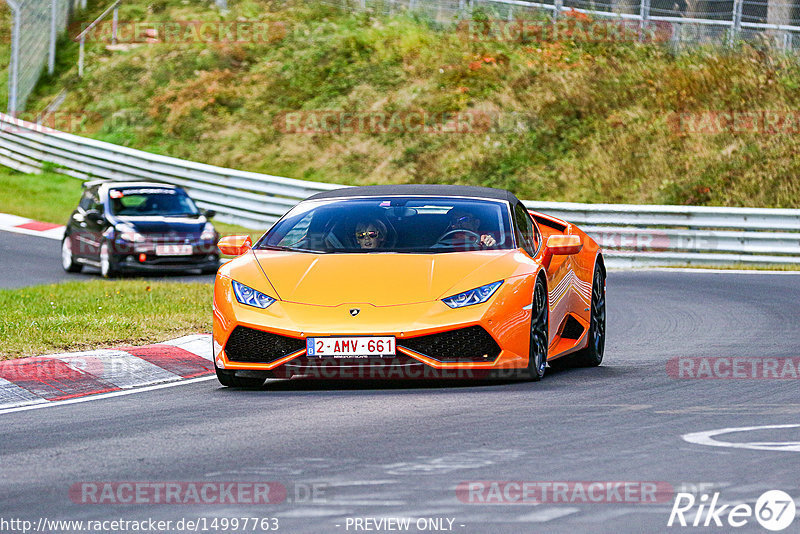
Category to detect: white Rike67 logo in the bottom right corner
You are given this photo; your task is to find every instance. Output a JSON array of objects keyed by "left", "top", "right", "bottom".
[{"left": 667, "top": 490, "right": 795, "bottom": 532}]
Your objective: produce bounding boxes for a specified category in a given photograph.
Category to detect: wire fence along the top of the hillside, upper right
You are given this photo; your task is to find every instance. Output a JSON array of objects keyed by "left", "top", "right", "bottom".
[{"left": 323, "top": 0, "right": 800, "bottom": 51}]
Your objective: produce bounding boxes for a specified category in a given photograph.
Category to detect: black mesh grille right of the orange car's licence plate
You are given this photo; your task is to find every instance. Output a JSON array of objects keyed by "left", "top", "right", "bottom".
[{"left": 397, "top": 326, "right": 500, "bottom": 362}]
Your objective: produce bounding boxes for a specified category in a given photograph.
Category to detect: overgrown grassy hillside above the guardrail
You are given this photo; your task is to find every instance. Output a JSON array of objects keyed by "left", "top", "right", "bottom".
[{"left": 4, "top": 0, "right": 800, "bottom": 208}]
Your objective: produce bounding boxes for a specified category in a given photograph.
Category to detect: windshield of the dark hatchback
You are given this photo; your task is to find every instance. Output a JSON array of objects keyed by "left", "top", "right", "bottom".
[{"left": 108, "top": 187, "right": 200, "bottom": 217}]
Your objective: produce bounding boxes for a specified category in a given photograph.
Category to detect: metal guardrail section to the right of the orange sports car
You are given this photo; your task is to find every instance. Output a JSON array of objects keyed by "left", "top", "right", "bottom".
[{"left": 524, "top": 201, "right": 800, "bottom": 266}]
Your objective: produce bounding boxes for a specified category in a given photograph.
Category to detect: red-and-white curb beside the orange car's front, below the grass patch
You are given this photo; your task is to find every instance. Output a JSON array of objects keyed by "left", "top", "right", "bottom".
[{"left": 0, "top": 334, "right": 214, "bottom": 410}]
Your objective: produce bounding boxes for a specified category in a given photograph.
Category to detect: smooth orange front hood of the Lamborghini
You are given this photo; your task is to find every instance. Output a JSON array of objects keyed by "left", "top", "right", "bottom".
[{"left": 253, "top": 250, "right": 517, "bottom": 306}]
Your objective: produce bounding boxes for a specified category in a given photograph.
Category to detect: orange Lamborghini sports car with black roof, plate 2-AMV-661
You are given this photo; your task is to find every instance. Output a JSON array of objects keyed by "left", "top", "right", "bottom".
[{"left": 213, "top": 185, "right": 606, "bottom": 387}]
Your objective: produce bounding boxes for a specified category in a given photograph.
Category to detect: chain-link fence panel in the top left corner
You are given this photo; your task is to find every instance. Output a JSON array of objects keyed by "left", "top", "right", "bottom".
[{"left": 6, "top": 0, "right": 72, "bottom": 113}]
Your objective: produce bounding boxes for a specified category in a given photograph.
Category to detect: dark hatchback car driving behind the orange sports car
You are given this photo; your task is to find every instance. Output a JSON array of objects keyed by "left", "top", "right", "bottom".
[{"left": 61, "top": 180, "right": 219, "bottom": 277}]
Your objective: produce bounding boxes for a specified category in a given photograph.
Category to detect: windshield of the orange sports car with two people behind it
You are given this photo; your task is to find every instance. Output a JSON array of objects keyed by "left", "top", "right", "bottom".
[{"left": 254, "top": 197, "right": 514, "bottom": 253}]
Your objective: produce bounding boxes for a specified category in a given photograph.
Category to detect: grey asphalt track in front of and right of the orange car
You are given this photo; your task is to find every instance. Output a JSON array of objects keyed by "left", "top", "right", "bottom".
[{"left": 0, "top": 228, "right": 800, "bottom": 533}]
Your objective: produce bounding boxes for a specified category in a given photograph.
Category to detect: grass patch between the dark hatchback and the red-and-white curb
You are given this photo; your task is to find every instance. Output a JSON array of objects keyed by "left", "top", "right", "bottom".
[{"left": 0, "top": 280, "right": 212, "bottom": 359}]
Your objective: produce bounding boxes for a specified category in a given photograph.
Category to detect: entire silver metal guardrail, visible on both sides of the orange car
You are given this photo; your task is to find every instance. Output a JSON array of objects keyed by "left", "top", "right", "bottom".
[{"left": 0, "top": 113, "right": 800, "bottom": 267}]
